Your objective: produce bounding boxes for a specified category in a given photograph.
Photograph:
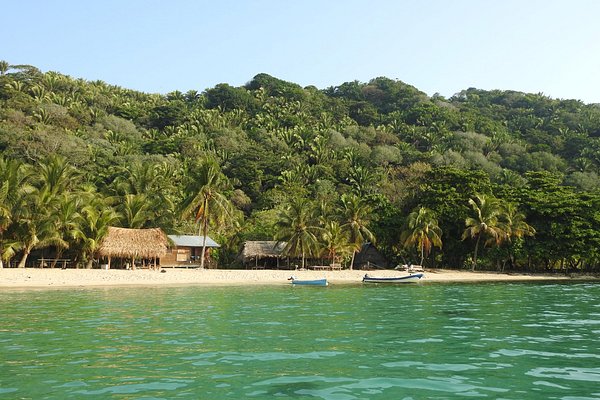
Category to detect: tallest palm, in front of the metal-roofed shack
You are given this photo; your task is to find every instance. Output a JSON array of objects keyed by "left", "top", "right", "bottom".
[{"left": 182, "top": 159, "right": 235, "bottom": 269}]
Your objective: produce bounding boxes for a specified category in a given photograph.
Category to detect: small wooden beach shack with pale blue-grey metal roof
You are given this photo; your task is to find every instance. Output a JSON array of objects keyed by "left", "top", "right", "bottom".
[{"left": 160, "top": 235, "right": 221, "bottom": 267}]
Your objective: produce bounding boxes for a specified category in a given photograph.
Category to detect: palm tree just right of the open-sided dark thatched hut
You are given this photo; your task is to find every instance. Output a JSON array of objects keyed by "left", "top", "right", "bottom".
[{"left": 275, "top": 198, "right": 318, "bottom": 268}]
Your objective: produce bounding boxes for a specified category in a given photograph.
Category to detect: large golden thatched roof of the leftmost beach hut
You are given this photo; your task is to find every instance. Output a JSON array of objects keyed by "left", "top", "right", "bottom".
[{"left": 98, "top": 227, "right": 168, "bottom": 258}]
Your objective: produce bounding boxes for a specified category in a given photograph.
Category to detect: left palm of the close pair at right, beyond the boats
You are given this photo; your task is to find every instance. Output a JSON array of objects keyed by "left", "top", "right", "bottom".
[{"left": 462, "top": 195, "right": 506, "bottom": 271}]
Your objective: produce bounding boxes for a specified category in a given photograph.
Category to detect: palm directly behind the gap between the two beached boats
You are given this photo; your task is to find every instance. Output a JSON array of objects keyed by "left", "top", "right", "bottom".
[{"left": 341, "top": 194, "right": 375, "bottom": 269}]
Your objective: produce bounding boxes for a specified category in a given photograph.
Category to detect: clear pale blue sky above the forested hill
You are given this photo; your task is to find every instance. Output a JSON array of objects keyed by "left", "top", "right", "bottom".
[{"left": 0, "top": 0, "right": 600, "bottom": 103}]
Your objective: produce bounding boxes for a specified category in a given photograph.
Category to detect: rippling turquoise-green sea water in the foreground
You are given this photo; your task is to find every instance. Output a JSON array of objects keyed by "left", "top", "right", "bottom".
[{"left": 0, "top": 283, "right": 600, "bottom": 400}]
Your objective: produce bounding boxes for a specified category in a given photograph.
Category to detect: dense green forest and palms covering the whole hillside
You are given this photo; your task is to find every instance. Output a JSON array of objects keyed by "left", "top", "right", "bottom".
[{"left": 0, "top": 62, "right": 600, "bottom": 272}]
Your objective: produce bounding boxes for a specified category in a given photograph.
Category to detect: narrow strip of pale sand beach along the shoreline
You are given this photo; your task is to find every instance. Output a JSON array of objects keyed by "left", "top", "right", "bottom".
[{"left": 0, "top": 268, "right": 583, "bottom": 289}]
